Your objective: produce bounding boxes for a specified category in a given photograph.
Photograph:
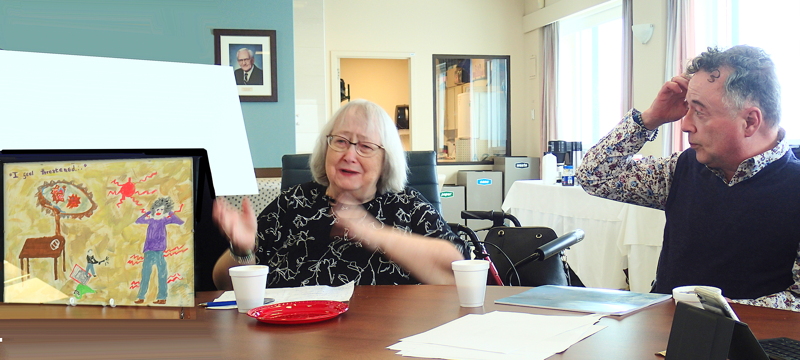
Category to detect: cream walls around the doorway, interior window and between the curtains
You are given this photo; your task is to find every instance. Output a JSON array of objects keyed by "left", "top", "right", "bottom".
[{"left": 294, "top": 0, "right": 666, "bottom": 170}]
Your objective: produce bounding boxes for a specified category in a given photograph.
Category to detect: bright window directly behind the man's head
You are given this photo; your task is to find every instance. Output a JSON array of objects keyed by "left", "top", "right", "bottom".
[{"left": 692, "top": 0, "right": 800, "bottom": 145}]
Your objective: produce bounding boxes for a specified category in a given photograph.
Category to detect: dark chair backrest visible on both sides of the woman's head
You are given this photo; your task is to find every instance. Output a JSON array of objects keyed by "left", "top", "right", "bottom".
[{"left": 281, "top": 150, "right": 442, "bottom": 212}]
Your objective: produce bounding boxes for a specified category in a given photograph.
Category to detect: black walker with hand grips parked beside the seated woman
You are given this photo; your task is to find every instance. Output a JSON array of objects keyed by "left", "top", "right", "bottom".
[{"left": 450, "top": 211, "right": 584, "bottom": 286}]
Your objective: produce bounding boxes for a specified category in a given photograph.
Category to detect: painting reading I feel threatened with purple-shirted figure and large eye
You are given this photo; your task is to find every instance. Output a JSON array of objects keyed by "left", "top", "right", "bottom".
[{"left": 3, "top": 158, "right": 194, "bottom": 306}]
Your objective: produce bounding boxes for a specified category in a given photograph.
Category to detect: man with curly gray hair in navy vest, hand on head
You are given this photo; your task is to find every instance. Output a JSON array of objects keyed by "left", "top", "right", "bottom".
[{"left": 577, "top": 45, "right": 800, "bottom": 311}]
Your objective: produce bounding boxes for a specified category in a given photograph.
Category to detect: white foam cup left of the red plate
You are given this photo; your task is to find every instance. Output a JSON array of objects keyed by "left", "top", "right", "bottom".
[{"left": 228, "top": 265, "right": 269, "bottom": 313}]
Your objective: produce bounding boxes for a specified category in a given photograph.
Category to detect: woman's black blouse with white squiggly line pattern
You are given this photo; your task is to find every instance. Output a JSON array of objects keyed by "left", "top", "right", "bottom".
[{"left": 256, "top": 182, "right": 464, "bottom": 287}]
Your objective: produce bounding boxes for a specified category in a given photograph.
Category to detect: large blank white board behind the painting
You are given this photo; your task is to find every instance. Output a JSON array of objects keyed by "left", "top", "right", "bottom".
[{"left": 0, "top": 50, "right": 258, "bottom": 196}]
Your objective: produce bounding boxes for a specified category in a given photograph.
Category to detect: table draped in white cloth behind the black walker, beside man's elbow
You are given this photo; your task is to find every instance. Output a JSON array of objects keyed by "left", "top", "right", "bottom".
[{"left": 503, "top": 180, "right": 665, "bottom": 292}]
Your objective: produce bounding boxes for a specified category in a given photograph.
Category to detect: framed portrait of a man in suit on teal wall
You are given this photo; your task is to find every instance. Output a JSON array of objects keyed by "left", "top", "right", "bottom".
[{"left": 214, "top": 29, "right": 278, "bottom": 102}]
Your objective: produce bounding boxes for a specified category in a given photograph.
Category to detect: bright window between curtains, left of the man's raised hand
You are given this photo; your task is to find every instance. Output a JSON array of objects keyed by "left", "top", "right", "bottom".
[{"left": 556, "top": 1, "right": 623, "bottom": 148}]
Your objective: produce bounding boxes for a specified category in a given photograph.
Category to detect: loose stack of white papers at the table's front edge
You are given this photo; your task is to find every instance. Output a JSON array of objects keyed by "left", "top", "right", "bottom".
[{"left": 389, "top": 311, "right": 605, "bottom": 360}]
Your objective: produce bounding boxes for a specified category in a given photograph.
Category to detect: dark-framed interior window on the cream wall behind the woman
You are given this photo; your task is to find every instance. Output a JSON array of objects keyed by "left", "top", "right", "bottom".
[{"left": 433, "top": 55, "right": 511, "bottom": 164}]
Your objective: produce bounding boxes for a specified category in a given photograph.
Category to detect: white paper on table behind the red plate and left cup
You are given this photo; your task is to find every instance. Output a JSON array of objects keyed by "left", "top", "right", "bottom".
[{"left": 208, "top": 281, "right": 355, "bottom": 310}]
